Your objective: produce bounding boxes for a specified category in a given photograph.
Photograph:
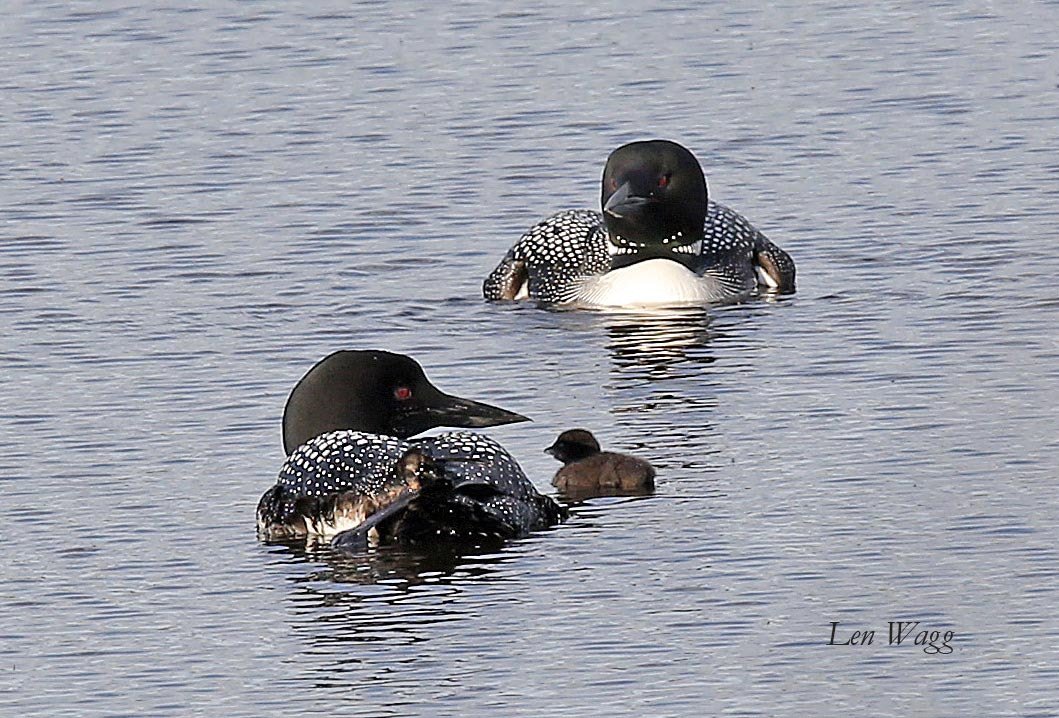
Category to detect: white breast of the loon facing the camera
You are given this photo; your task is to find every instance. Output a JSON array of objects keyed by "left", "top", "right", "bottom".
[{"left": 574, "top": 259, "right": 728, "bottom": 307}]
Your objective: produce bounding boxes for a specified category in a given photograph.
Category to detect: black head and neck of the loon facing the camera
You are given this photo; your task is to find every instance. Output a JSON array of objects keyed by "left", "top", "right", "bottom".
[{"left": 602, "top": 140, "right": 707, "bottom": 269}]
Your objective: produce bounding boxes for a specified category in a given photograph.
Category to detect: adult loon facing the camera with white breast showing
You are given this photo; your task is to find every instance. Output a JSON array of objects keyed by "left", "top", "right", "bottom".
[{"left": 482, "top": 140, "right": 794, "bottom": 307}]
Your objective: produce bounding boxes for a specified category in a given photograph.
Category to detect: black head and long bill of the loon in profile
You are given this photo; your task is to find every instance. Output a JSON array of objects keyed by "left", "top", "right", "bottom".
[{"left": 283, "top": 351, "right": 530, "bottom": 454}]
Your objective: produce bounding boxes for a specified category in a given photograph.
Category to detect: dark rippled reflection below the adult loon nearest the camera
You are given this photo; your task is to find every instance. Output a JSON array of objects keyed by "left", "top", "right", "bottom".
[{"left": 268, "top": 537, "right": 539, "bottom": 690}]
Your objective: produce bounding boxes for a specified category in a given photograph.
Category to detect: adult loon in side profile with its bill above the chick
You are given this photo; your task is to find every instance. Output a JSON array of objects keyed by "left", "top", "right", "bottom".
[{"left": 257, "top": 351, "right": 564, "bottom": 550}]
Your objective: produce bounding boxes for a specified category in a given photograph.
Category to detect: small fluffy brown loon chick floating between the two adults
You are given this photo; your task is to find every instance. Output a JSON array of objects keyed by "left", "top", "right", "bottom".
[{"left": 544, "top": 429, "right": 654, "bottom": 498}]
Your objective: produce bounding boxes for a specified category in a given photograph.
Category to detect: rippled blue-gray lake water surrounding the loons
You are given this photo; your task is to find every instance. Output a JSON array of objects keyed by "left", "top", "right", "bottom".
[{"left": 0, "top": 0, "right": 1059, "bottom": 717}]
